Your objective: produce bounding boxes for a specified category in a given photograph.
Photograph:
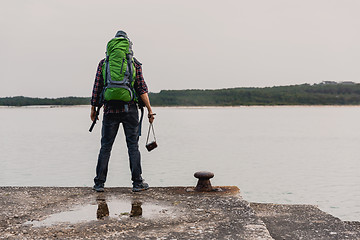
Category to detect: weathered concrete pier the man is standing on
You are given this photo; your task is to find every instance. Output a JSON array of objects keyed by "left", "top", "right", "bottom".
[{"left": 0, "top": 186, "right": 360, "bottom": 240}]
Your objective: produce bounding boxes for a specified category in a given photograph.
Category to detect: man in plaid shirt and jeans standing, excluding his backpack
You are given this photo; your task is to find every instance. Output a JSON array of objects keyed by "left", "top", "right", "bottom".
[{"left": 90, "top": 31, "right": 155, "bottom": 192}]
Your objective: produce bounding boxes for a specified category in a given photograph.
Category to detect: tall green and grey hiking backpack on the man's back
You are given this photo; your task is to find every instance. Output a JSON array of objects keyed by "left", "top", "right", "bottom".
[{"left": 102, "top": 31, "right": 137, "bottom": 102}]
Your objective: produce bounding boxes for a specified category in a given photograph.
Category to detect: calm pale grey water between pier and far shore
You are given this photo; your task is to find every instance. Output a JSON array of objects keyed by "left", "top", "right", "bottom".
[{"left": 0, "top": 106, "right": 360, "bottom": 221}]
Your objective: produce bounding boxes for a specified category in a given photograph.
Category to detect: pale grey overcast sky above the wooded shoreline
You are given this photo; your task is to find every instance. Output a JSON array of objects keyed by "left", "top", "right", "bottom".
[{"left": 0, "top": 0, "right": 360, "bottom": 97}]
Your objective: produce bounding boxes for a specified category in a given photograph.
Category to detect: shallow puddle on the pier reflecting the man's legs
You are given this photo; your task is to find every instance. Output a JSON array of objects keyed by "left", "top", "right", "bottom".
[{"left": 24, "top": 199, "right": 175, "bottom": 227}]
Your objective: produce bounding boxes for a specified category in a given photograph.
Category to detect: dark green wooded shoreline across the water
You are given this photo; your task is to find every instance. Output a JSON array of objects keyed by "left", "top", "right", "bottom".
[{"left": 0, "top": 82, "right": 360, "bottom": 106}]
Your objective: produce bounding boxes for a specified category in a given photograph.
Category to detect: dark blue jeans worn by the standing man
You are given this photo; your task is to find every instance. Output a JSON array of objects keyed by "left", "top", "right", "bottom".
[{"left": 94, "top": 105, "right": 142, "bottom": 186}]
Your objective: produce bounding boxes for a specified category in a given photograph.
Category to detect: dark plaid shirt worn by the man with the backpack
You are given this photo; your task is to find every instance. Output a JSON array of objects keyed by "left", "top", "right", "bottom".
[{"left": 91, "top": 58, "right": 148, "bottom": 114}]
